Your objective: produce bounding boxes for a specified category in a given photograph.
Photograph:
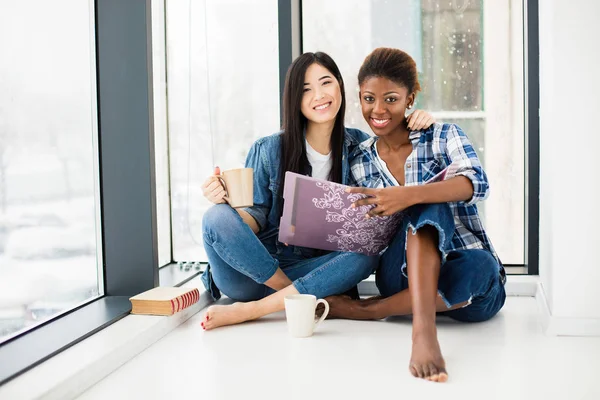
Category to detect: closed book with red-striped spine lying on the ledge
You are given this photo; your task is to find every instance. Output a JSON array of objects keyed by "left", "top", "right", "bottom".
[{"left": 129, "top": 287, "right": 200, "bottom": 315}]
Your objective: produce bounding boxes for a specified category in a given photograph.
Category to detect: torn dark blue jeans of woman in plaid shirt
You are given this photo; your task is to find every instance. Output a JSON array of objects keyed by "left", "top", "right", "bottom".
[{"left": 376, "top": 204, "right": 506, "bottom": 322}]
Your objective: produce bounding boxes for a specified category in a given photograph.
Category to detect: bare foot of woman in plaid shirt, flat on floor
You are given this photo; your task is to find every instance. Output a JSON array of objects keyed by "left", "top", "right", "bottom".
[{"left": 409, "top": 327, "right": 448, "bottom": 382}]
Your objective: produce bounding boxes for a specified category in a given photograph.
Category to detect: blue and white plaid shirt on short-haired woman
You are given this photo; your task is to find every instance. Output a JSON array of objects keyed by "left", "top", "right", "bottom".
[{"left": 350, "top": 123, "right": 500, "bottom": 262}]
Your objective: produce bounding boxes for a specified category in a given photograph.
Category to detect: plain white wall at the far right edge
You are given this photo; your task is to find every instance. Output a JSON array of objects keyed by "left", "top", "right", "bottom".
[{"left": 539, "top": 0, "right": 600, "bottom": 319}]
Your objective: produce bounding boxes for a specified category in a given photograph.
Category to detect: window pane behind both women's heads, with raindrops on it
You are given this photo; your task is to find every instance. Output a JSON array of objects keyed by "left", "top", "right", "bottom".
[{"left": 302, "top": 0, "right": 525, "bottom": 264}]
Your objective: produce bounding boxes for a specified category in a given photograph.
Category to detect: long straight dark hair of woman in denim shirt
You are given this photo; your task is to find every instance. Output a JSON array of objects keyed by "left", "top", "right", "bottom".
[{"left": 279, "top": 52, "right": 346, "bottom": 205}]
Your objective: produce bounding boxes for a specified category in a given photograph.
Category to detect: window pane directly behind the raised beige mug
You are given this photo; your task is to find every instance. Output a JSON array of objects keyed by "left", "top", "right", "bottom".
[{"left": 166, "top": 0, "right": 279, "bottom": 261}]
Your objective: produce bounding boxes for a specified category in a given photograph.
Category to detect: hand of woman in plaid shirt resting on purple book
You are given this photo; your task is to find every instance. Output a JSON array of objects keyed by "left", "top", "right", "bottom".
[{"left": 346, "top": 186, "right": 419, "bottom": 218}]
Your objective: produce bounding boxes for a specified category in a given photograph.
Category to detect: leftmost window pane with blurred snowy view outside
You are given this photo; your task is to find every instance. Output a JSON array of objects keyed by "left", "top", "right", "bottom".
[{"left": 0, "top": 0, "right": 102, "bottom": 341}]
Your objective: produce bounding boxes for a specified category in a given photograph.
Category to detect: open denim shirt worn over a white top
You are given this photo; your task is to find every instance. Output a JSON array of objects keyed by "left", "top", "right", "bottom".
[{"left": 244, "top": 128, "right": 369, "bottom": 257}]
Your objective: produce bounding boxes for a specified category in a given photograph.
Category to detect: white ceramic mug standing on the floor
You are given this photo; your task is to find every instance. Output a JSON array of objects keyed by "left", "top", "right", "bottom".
[{"left": 285, "top": 294, "right": 329, "bottom": 337}]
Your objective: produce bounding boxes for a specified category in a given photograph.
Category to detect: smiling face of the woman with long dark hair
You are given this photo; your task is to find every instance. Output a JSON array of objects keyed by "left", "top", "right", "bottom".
[{"left": 300, "top": 63, "right": 342, "bottom": 124}]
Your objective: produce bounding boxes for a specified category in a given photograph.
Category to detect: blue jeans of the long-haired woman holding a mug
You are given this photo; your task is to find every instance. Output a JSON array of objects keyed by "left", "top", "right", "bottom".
[{"left": 202, "top": 204, "right": 379, "bottom": 301}]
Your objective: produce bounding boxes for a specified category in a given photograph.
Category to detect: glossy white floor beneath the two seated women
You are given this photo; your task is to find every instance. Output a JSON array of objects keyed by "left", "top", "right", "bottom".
[{"left": 79, "top": 297, "right": 600, "bottom": 400}]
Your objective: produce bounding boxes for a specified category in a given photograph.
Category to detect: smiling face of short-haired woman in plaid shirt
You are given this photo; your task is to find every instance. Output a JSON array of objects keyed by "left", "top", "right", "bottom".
[{"left": 360, "top": 76, "right": 415, "bottom": 136}]
